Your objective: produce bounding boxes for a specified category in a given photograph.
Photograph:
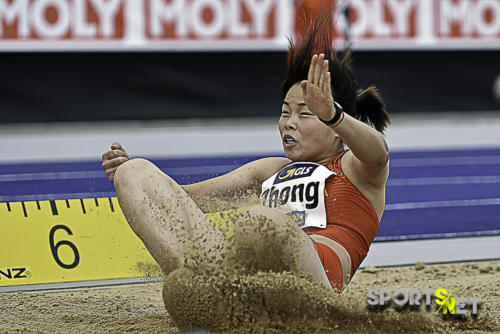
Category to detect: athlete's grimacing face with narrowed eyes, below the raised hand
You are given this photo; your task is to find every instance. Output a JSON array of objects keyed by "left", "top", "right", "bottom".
[{"left": 279, "top": 84, "right": 340, "bottom": 164}]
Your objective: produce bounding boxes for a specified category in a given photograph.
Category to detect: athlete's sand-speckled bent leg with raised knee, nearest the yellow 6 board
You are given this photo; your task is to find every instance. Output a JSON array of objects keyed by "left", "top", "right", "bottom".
[{"left": 114, "top": 159, "right": 225, "bottom": 274}]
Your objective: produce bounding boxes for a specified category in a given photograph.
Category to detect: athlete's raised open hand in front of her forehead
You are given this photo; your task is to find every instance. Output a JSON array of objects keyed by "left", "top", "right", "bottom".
[{"left": 300, "top": 53, "right": 335, "bottom": 121}]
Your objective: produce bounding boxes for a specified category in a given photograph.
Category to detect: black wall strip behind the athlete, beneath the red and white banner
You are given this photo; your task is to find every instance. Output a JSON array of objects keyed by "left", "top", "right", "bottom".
[{"left": 0, "top": 51, "right": 500, "bottom": 123}]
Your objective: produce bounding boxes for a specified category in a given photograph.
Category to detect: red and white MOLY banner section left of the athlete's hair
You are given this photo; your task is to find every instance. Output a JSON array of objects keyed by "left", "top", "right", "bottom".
[{"left": 0, "top": 0, "right": 293, "bottom": 50}]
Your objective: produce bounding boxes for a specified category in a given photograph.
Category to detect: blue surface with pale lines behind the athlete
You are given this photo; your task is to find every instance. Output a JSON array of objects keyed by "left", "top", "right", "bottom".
[{"left": 0, "top": 149, "right": 500, "bottom": 241}]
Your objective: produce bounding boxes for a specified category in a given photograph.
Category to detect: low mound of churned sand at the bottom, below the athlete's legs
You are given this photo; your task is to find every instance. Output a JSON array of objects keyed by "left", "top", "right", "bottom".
[{"left": 163, "top": 268, "right": 444, "bottom": 333}]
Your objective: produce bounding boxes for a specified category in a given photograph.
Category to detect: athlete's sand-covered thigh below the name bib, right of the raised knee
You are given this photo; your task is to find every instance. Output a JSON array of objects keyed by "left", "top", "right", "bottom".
[{"left": 234, "top": 206, "right": 331, "bottom": 288}]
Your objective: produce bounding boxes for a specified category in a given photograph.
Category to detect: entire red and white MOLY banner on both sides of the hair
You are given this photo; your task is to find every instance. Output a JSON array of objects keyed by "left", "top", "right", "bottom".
[{"left": 0, "top": 0, "right": 500, "bottom": 51}]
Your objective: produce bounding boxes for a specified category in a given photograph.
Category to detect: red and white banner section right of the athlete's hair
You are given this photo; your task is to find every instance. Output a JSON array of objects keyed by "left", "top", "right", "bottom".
[{"left": 336, "top": 0, "right": 500, "bottom": 49}]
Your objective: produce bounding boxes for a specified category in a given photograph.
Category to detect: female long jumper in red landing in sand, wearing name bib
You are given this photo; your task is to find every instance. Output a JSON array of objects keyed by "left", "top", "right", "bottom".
[{"left": 102, "top": 19, "right": 390, "bottom": 292}]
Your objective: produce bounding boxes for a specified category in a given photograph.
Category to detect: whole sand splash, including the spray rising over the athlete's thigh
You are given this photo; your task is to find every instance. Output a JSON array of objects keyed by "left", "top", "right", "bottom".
[{"left": 163, "top": 211, "right": 435, "bottom": 333}]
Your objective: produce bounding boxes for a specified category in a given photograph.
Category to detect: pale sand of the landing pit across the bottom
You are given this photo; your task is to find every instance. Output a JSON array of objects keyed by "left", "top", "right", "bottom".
[{"left": 0, "top": 261, "right": 500, "bottom": 333}]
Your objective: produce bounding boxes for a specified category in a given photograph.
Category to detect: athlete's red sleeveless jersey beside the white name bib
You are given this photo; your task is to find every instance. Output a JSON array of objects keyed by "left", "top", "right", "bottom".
[{"left": 304, "top": 150, "right": 379, "bottom": 277}]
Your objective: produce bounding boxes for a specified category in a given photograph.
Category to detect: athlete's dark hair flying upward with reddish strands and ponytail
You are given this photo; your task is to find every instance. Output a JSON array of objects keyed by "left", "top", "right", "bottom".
[{"left": 281, "top": 9, "right": 391, "bottom": 132}]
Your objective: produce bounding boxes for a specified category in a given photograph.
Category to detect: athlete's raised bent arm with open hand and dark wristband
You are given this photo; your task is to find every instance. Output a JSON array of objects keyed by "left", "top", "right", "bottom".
[{"left": 301, "top": 54, "right": 389, "bottom": 187}]
